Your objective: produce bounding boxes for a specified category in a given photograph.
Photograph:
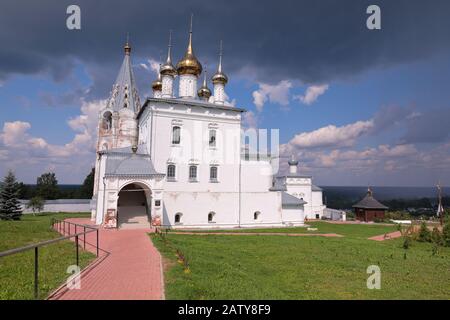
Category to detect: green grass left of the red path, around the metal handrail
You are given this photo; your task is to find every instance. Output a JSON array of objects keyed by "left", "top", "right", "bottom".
[{"left": 0, "top": 213, "right": 95, "bottom": 300}]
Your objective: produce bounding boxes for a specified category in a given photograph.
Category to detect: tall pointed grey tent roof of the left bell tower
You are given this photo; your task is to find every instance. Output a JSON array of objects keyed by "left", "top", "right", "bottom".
[{"left": 108, "top": 44, "right": 141, "bottom": 113}]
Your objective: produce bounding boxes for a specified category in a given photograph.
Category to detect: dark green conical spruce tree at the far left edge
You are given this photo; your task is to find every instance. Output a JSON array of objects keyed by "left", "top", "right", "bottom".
[{"left": 0, "top": 171, "right": 22, "bottom": 220}]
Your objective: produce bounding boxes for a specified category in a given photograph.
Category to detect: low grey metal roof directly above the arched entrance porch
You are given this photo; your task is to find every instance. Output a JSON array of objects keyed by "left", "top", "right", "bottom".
[{"left": 105, "top": 152, "right": 164, "bottom": 177}]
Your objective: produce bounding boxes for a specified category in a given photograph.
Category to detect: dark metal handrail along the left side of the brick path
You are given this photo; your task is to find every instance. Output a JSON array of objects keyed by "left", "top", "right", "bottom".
[{"left": 0, "top": 218, "right": 99, "bottom": 299}]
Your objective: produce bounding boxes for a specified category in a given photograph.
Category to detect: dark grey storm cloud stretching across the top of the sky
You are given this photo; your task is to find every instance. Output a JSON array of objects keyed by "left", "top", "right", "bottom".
[{"left": 0, "top": 0, "right": 450, "bottom": 96}]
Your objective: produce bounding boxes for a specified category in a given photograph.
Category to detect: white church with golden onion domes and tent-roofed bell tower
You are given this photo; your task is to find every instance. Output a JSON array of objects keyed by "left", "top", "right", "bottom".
[{"left": 91, "top": 28, "right": 325, "bottom": 229}]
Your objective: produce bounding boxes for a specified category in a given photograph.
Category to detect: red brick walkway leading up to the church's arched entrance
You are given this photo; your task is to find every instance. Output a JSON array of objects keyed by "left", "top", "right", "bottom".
[{"left": 50, "top": 218, "right": 164, "bottom": 300}]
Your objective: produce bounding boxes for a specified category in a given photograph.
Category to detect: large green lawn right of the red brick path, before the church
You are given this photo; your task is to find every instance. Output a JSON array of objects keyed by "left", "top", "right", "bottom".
[{"left": 152, "top": 222, "right": 450, "bottom": 299}]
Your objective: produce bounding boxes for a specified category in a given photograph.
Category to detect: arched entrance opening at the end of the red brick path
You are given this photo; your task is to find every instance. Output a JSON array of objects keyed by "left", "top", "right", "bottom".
[{"left": 117, "top": 183, "right": 152, "bottom": 229}]
